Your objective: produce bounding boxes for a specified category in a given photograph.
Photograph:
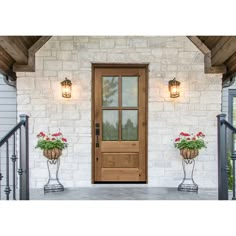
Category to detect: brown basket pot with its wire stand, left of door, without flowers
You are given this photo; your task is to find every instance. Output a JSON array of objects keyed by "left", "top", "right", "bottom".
[{"left": 43, "top": 148, "right": 64, "bottom": 193}]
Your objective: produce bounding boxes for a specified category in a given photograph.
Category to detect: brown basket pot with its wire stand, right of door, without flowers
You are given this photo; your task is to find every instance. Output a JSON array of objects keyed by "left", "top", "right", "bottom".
[{"left": 178, "top": 149, "right": 199, "bottom": 192}]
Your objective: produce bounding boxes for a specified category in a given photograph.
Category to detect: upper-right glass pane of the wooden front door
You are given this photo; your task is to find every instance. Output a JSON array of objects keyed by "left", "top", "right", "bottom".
[{"left": 122, "top": 76, "right": 138, "bottom": 107}]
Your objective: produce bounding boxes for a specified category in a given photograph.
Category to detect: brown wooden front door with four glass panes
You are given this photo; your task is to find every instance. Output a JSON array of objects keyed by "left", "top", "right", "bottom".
[{"left": 93, "top": 66, "right": 147, "bottom": 183}]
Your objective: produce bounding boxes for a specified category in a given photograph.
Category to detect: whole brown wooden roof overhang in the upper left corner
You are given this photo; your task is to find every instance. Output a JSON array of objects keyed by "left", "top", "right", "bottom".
[{"left": 0, "top": 36, "right": 50, "bottom": 80}]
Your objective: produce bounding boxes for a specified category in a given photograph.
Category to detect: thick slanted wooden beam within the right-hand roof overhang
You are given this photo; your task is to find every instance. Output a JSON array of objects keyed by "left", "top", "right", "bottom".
[{"left": 211, "top": 36, "right": 236, "bottom": 66}]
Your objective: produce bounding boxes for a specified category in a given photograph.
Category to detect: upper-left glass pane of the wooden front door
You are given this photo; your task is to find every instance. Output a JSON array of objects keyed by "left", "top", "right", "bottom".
[{"left": 102, "top": 76, "right": 118, "bottom": 107}]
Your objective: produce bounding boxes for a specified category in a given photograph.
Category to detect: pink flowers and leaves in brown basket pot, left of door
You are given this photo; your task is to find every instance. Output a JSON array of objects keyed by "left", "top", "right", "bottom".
[{"left": 36, "top": 132, "right": 68, "bottom": 159}]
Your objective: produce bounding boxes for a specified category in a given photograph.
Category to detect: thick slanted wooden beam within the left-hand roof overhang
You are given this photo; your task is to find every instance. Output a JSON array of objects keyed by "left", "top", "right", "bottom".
[{"left": 0, "top": 36, "right": 28, "bottom": 64}]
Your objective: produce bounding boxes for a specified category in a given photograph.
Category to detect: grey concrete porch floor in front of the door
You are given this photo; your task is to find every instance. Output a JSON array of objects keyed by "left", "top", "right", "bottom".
[{"left": 30, "top": 187, "right": 218, "bottom": 200}]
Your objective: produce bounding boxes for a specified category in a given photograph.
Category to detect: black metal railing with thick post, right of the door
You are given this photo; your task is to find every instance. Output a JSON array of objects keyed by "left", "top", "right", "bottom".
[{"left": 217, "top": 114, "right": 236, "bottom": 200}]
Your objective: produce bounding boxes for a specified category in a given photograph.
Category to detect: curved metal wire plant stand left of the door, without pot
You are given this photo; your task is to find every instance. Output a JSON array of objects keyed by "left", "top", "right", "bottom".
[{"left": 44, "top": 158, "right": 64, "bottom": 193}]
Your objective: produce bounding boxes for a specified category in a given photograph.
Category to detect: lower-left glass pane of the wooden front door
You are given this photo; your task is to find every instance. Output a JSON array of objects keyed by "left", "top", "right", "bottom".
[{"left": 102, "top": 110, "right": 119, "bottom": 141}]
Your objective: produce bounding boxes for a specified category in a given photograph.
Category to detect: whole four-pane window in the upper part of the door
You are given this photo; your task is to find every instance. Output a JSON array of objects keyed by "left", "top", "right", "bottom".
[{"left": 102, "top": 75, "right": 139, "bottom": 141}]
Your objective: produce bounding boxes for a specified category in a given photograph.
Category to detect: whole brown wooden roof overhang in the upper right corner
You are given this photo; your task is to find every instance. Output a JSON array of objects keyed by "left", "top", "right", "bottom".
[{"left": 188, "top": 36, "right": 236, "bottom": 84}]
